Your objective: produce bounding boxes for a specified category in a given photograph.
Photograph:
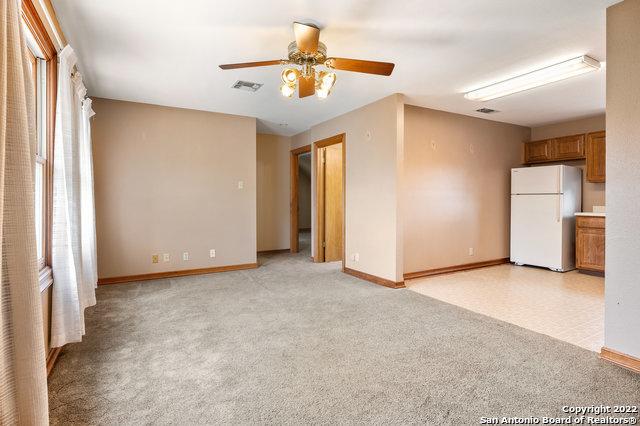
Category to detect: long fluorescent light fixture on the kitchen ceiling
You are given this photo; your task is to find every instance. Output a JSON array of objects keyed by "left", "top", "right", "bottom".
[{"left": 464, "top": 56, "right": 600, "bottom": 101}]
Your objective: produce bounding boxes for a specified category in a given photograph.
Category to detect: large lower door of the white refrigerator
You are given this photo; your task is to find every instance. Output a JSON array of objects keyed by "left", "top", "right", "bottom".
[{"left": 511, "top": 194, "right": 563, "bottom": 270}]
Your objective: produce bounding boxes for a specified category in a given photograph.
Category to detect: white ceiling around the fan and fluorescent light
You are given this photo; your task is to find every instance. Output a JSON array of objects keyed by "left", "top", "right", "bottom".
[{"left": 53, "top": 0, "right": 617, "bottom": 135}]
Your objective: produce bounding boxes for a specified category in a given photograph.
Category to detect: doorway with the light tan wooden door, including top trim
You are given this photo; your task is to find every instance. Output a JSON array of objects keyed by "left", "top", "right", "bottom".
[{"left": 313, "top": 134, "right": 346, "bottom": 265}]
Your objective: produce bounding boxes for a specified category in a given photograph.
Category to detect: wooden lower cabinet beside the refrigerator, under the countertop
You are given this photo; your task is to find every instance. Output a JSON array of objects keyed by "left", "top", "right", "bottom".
[{"left": 576, "top": 216, "right": 605, "bottom": 272}]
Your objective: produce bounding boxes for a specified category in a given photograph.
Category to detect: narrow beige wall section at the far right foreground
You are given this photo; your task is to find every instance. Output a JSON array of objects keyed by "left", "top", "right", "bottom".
[{"left": 604, "top": 0, "right": 640, "bottom": 358}]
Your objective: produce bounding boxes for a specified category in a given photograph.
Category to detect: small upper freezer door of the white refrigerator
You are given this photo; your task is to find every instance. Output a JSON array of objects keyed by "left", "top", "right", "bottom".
[{"left": 511, "top": 166, "right": 562, "bottom": 194}]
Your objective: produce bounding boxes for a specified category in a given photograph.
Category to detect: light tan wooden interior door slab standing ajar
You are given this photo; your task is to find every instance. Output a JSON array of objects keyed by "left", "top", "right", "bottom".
[{"left": 322, "top": 143, "right": 344, "bottom": 262}]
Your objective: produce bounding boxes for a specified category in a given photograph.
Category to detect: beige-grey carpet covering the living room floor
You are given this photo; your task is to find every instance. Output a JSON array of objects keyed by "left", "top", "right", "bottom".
[{"left": 49, "top": 253, "right": 640, "bottom": 425}]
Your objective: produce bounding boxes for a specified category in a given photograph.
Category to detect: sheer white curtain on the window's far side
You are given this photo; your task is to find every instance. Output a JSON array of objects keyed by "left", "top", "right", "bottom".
[{"left": 51, "top": 46, "right": 97, "bottom": 347}]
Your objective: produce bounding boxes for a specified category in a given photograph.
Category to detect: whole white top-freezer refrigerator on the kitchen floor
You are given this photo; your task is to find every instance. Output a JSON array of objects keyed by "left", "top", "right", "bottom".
[{"left": 511, "top": 165, "right": 582, "bottom": 272}]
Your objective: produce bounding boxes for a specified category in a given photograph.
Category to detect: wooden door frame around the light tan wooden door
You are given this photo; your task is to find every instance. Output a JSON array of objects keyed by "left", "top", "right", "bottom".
[{"left": 313, "top": 133, "right": 347, "bottom": 270}]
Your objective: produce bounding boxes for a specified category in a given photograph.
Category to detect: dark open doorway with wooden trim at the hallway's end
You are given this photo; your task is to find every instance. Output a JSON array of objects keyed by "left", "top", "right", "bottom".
[{"left": 290, "top": 145, "right": 311, "bottom": 255}]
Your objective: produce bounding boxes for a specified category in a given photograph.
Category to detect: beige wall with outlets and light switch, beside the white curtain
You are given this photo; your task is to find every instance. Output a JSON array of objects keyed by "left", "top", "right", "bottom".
[{"left": 92, "top": 99, "right": 256, "bottom": 278}]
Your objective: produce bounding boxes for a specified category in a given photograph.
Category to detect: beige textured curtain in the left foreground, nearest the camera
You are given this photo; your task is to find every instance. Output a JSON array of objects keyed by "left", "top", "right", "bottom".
[{"left": 0, "top": 0, "right": 48, "bottom": 425}]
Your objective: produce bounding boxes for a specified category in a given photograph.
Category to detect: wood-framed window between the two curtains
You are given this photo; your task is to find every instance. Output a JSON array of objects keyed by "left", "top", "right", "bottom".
[{"left": 22, "top": 0, "right": 57, "bottom": 290}]
